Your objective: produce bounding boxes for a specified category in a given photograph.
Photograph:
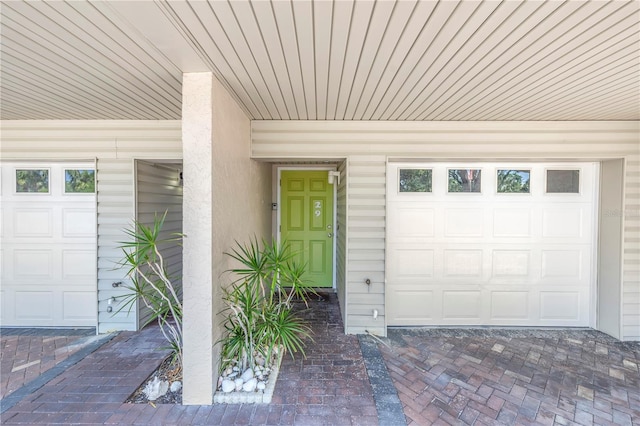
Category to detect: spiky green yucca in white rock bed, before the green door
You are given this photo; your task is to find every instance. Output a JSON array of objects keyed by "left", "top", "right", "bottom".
[{"left": 221, "top": 238, "right": 313, "bottom": 370}]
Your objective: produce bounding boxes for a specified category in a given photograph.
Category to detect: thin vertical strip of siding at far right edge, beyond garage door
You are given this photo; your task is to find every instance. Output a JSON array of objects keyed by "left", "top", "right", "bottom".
[{"left": 622, "top": 154, "right": 640, "bottom": 340}]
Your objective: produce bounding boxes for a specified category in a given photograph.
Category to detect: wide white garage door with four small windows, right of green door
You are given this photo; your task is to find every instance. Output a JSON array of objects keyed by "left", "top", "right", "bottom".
[{"left": 386, "top": 163, "right": 597, "bottom": 326}]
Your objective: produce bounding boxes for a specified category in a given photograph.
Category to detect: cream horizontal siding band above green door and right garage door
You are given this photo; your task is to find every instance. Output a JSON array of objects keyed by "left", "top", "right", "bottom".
[{"left": 251, "top": 121, "right": 640, "bottom": 159}]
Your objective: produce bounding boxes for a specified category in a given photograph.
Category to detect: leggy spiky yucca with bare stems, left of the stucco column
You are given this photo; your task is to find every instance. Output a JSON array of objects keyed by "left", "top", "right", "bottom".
[{"left": 117, "top": 211, "right": 183, "bottom": 369}]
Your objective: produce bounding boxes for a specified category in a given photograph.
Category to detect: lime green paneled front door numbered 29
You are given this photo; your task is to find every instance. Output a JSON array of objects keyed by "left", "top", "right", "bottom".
[{"left": 280, "top": 170, "right": 334, "bottom": 287}]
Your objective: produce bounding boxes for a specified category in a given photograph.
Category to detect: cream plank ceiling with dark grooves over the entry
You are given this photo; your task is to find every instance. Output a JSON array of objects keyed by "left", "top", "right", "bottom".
[{"left": 0, "top": 0, "right": 640, "bottom": 120}]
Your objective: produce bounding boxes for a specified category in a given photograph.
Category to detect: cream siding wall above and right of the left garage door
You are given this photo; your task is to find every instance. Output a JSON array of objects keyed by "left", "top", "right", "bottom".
[{"left": 0, "top": 120, "right": 182, "bottom": 333}]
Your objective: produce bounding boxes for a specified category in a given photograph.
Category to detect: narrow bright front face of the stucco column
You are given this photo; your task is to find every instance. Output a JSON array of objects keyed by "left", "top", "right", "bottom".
[{"left": 182, "top": 73, "right": 215, "bottom": 405}]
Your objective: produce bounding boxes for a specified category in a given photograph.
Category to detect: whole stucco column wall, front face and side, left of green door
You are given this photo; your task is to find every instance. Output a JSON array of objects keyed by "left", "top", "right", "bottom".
[{"left": 182, "top": 73, "right": 271, "bottom": 404}]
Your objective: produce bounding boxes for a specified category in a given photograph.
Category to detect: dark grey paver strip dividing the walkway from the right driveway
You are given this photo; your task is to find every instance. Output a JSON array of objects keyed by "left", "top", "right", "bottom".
[{"left": 358, "top": 334, "right": 407, "bottom": 426}]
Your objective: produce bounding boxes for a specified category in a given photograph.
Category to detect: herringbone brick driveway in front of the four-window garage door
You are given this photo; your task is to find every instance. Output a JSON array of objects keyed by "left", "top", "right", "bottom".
[{"left": 379, "top": 329, "right": 640, "bottom": 425}]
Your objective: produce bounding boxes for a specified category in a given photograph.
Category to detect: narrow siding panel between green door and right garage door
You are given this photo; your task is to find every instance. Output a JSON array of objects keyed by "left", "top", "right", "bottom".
[{"left": 346, "top": 156, "right": 386, "bottom": 335}]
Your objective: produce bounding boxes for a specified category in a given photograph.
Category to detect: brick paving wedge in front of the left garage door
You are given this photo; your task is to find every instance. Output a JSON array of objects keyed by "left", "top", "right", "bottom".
[{"left": 0, "top": 328, "right": 95, "bottom": 398}]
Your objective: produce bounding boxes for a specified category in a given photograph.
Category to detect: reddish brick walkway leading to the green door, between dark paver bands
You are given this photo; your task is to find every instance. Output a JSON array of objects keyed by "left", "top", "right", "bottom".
[{"left": 1, "top": 294, "right": 378, "bottom": 426}]
